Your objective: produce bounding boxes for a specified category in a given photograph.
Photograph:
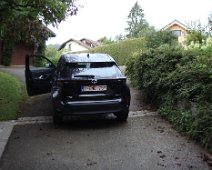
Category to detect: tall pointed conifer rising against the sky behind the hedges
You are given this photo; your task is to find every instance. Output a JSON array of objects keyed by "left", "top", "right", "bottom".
[{"left": 125, "top": 2, "right": 148, "bottom": 38}]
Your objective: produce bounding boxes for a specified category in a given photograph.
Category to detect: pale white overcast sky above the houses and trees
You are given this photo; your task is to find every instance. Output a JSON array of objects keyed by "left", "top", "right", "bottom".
[{"left": 47, "top": 0, "right": 212, "bottom": 44}]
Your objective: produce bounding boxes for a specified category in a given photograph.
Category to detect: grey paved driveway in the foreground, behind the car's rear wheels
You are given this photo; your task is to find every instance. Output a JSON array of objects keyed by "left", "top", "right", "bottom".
[{"left": 0, "top": 115, "right": 211, "bottom": 170}]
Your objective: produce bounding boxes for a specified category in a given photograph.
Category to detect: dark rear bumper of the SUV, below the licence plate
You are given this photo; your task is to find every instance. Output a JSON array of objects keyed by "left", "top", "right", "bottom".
[{"left": 55, "top": 98, "right": 129, "bottom": 115}]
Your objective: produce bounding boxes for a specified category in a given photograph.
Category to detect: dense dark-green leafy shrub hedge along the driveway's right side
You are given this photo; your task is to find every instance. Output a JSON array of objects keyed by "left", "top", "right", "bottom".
[{"left": 126, "top": 45, "right": 212, "bottom": 151}]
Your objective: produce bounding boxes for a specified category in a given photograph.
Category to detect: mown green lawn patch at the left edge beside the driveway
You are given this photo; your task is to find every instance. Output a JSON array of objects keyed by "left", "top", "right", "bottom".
[{"left": 0, "top": 72, "right": 26, "bottom": 121}]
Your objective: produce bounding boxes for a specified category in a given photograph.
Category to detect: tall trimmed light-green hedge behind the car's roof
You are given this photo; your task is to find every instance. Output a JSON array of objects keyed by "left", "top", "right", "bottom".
[{"left": 90, "top": 38, "right": 145, "bottom": 65}]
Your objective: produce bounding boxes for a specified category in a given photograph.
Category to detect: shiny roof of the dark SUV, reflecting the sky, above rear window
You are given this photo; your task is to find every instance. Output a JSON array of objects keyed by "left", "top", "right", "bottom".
[{"left": 61, "top": 53, "right": 115, "bottom": 63}]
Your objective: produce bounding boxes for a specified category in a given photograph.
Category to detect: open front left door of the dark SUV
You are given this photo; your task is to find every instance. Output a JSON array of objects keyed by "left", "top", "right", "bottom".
[{"left": 25, "top": 55, "right": 56, "bottom": 96}]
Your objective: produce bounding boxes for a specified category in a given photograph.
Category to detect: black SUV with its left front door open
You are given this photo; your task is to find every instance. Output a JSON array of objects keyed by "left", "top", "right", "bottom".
[{"left": 25, "top": 53, "right": 130, "bottom": 123}]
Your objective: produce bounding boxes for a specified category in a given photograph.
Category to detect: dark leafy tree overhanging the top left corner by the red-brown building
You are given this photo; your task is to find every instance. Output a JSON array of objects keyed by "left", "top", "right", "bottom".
[{"left": 0, "top": 0, "right": 78, "bottom": 42}]
